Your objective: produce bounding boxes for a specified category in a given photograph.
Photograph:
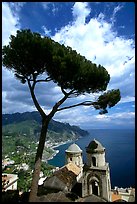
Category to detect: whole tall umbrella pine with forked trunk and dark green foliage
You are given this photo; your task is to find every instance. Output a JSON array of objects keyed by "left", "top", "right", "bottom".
[{"left": 2, "top": 30, "right": 121, "bottom": 201}]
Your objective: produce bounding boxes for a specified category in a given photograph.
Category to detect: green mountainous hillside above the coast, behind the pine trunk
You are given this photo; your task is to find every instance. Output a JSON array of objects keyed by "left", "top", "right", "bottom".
[{"left": 2, "top": 111, "right": 88, "bottom": 161}]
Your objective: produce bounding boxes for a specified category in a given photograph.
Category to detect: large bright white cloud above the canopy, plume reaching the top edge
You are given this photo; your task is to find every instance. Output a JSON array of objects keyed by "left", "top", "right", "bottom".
[{"left": 52, "top": 2, "right": 135, "bottom": 103}]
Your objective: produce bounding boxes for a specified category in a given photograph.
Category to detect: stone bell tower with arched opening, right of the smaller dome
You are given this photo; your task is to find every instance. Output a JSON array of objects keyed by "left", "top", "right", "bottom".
[{"left": 82, "top": 139, "right": 111, "bottom": 202}]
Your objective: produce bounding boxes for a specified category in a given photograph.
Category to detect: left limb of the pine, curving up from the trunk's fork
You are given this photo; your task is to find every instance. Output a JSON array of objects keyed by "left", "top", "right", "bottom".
[{"left": 27, "top": 79, "right": 47, "bottom": 118}]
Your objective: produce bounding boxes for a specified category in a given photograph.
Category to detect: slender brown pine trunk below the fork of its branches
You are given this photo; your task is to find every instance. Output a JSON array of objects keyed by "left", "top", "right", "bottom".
[{"left": 29, "top": 118, "right": 50, "bottom": 202}]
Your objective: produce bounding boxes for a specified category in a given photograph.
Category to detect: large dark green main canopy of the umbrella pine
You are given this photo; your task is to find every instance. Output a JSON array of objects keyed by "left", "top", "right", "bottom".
[{"left": 2, "top": 30, "right": 110, "bottom": 94}]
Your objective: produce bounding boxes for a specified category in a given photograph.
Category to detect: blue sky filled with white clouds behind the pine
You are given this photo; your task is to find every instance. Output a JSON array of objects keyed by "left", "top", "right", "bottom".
[{"left": 2, "top": 2, "right": 135, "bottom": 129}]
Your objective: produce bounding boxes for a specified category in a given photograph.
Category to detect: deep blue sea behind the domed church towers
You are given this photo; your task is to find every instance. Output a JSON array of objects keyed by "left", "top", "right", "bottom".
[{"left": 48, "top": 129, "right": 135, "bottom": 188}]
